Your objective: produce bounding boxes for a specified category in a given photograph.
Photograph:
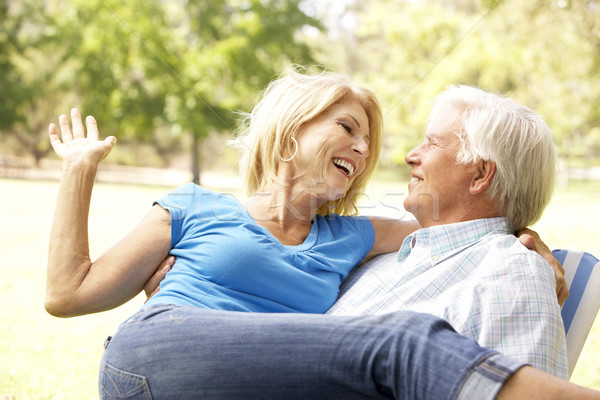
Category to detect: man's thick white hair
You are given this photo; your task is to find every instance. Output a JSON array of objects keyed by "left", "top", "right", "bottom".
[{"left": 429, "top": 86, "right": 557, "bottom": 230}]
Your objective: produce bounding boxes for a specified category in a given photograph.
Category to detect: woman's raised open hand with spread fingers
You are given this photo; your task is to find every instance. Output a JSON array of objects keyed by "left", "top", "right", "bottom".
[{"left": 48, "top": 108, "right": 117, "bottom": 165}]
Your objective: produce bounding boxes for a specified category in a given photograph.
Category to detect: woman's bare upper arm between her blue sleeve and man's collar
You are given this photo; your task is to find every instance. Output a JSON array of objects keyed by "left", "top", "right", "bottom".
[{"left": 363, "top": 217, "right": 421, "bottom": 261}]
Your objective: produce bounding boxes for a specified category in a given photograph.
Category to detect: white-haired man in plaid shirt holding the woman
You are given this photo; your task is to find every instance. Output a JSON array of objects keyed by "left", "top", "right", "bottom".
[{"left": 329, "top": 86, "right": 567, "bottom": 378}]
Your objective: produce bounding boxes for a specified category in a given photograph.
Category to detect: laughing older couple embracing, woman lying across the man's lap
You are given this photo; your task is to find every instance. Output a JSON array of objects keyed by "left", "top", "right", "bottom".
[{"left": 46, "top": 72, "right": 600, "bottom": 399}]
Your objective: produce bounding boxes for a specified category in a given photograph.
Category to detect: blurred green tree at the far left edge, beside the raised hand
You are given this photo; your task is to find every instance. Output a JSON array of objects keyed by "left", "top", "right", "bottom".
[{"left": 0, "top": 0, "right": 72, "bottom": 164}]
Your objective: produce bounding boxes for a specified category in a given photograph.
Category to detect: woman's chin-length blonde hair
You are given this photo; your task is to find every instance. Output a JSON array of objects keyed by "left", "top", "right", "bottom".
[{"left": 234, "top": 68, "right": 383, "bottom": 215}]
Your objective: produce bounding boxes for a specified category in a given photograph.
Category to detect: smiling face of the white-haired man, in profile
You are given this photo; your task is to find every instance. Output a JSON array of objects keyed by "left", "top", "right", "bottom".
[{"left": 404, "top": 107, "right": 475, "bottom": 227}]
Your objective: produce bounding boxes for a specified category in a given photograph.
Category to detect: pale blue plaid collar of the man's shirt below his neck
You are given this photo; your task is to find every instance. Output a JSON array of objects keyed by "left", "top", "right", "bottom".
[{"left": 398, "top": 217, "right": 513, "bottom": 262}]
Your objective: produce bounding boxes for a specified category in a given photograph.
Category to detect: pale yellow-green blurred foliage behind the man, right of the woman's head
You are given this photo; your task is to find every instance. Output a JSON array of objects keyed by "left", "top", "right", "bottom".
[{"left": 312, "top": 0, "right": 600, "bottom": 170}]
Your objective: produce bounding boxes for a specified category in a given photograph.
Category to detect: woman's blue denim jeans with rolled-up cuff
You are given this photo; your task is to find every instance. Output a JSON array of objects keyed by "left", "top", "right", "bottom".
[{"left": 99, "top": 306, "right": 523, "bottom": 400}]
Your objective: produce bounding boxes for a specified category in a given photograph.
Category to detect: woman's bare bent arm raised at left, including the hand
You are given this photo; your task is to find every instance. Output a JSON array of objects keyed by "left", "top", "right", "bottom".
[{"left": 45, "top": 109, "right": 171, "bottom": 317}]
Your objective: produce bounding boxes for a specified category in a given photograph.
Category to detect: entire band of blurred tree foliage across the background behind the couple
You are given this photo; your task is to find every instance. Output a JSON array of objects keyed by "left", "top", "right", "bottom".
[{"left": 0, "top": 0, "right": 600, "bottom": 177}]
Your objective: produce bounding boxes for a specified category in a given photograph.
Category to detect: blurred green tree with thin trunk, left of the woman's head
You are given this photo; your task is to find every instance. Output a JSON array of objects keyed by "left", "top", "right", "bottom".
[{"left": 152, "top": 0, "right": 318, "bottom": 181}]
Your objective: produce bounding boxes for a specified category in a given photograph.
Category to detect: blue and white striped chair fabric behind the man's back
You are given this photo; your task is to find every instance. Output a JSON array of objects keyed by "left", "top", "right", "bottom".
[{"left": 552, "top": 249, "right": 600, "bottom": 376}]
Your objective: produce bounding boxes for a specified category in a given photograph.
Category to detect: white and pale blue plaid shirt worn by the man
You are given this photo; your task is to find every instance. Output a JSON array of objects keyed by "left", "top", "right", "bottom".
[{"left": 328, "top": 218, "right": 568, "bottom": 379}]
